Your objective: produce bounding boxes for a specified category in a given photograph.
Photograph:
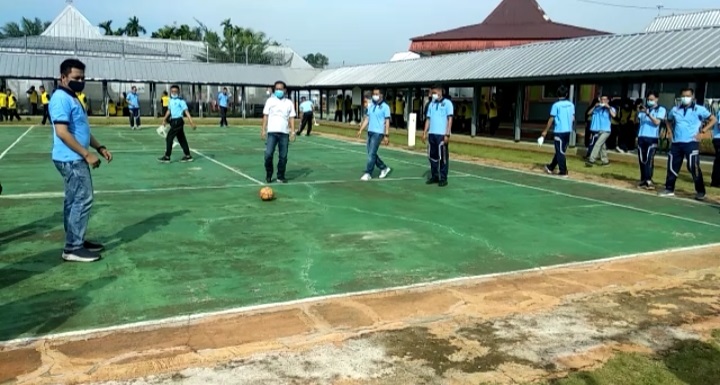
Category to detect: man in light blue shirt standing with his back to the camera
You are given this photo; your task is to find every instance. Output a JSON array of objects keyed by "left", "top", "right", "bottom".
[{"left": 540, "top": 86, "right": 575, "bottom": 178}]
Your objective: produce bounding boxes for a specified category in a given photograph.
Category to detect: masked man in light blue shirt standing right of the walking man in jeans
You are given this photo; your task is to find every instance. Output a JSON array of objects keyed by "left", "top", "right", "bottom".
[{"left": 422, "top": 85, "right": 454, "bottom": 187}]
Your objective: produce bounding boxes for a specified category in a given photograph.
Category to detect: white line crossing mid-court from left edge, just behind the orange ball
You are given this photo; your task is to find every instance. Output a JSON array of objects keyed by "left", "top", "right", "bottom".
[{"left": 0, "top": 175, "right": 472, "bottom": 200}]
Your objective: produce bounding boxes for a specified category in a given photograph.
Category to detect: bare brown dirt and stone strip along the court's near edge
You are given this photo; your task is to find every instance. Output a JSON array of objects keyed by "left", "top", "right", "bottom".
[{"left": 0, "top": 246, "right": 720, "bottom": 385}]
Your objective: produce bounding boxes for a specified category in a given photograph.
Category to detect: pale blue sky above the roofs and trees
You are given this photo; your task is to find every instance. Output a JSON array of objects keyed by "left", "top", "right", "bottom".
[{"left": 0, "top": 0, "right": 720, "bottom": 66}]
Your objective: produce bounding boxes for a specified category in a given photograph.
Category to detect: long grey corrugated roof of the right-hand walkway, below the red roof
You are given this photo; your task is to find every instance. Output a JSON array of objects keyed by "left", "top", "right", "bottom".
[{"left": 308, "top": 27, "right": 720, "bottom": 87}]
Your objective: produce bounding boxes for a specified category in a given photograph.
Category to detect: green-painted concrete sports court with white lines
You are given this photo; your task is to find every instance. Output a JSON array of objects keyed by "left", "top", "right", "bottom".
[{"left": 0, "top": 126, "right": 720, "bottom": 341}]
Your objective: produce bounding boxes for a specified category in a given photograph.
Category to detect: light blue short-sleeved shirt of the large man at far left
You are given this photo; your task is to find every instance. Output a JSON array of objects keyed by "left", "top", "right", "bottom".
[{"left": 48, "top": 87, "right": 90, "bottom": 162}]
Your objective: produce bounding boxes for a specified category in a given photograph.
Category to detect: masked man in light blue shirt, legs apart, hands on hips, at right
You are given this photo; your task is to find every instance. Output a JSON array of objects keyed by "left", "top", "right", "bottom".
[{"left": 659, "top": 88, "right": 717, "bottom": 201}]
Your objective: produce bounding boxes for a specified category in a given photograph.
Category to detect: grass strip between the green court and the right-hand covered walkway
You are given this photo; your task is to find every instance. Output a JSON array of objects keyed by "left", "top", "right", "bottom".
[{"left": 313, "top": 126, "right": 720, "bottom": 198}]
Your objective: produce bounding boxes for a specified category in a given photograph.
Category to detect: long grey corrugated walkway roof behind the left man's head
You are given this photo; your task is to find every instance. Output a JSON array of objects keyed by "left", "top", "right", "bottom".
[{"left": 0, "top": 54, "right": 320, "bottom": 87}]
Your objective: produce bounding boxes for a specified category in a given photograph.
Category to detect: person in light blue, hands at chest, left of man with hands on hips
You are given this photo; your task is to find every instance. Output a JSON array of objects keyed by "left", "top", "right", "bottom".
[{"left": 637, "top": 91, "right": 667, "bottom": 190}]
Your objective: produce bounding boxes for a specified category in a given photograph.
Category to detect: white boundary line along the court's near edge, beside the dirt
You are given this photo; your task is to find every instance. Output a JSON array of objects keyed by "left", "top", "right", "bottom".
[{"left": 0, "top": 242, "right": 720, "bottom": 349}]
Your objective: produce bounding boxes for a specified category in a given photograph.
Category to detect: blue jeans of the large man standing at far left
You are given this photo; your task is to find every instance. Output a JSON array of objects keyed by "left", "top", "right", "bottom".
[{"left": 53, "top": 160, "right": 93, "bottom": 251}]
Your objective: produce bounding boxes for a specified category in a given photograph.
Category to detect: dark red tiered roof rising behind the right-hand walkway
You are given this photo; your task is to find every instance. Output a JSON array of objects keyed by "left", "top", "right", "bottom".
[{"left": 410, "top": 0, "right": 608, "bottom": 42}]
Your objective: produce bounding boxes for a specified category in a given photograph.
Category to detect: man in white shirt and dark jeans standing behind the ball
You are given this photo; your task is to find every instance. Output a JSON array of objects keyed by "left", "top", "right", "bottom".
[{"left": 260, "top": 81, "right": 296, "bottom": 183}]
